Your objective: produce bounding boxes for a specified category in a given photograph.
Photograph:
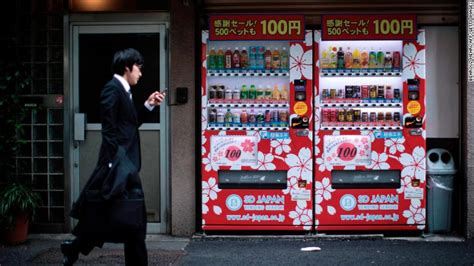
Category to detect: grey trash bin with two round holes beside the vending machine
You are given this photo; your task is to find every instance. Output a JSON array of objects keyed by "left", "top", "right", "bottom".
[{"left": 427, "top": 149, "right": 456, "bottom": 233}]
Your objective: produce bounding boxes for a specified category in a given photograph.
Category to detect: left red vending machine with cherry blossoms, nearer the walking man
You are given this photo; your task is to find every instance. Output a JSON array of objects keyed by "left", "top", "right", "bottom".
[{"left": 201, "top": 15, "right": 314, "bottom": 231}]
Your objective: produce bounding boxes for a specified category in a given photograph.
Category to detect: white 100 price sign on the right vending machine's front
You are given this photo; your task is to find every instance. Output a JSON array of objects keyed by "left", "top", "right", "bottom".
[{"left": 323, "top": 135, "right": 371, "bottom": 165}]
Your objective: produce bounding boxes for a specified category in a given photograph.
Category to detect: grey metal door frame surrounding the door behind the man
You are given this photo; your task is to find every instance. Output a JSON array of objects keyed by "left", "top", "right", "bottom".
[{"left": 64, "top": 13, "right": 171, "bottom": 234}]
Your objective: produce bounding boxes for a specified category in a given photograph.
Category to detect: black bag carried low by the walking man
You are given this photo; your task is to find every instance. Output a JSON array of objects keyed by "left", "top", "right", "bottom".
[{"left": 81, "top": 190, "right": 146, "bottom": 233}]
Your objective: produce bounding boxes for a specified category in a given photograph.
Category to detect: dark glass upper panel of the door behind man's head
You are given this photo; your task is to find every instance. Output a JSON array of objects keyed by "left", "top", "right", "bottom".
[{"left": 78, "top": 33, "right": 160, "bottom": 123}]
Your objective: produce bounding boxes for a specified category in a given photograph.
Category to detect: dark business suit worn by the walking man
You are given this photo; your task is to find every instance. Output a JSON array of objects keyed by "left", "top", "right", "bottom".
[{"left": 71, "top": 78, "right": 151, "bottom": 265}]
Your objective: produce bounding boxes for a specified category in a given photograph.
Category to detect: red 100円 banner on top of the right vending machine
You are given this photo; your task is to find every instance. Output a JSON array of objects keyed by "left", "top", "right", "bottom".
[{"left": 321, "top": 15, "right": 417, "bottom": 41}]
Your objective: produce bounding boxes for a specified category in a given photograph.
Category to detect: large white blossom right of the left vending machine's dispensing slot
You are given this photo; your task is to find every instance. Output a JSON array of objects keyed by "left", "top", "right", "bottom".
[{"left": 285, "top": 148, "right": 313, "bottom": 183}]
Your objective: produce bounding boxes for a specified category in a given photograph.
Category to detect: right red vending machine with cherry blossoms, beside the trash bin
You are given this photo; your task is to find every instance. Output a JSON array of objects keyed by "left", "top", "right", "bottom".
[{"left": 314, "top": 15, "right": 426, "bottom": 231}]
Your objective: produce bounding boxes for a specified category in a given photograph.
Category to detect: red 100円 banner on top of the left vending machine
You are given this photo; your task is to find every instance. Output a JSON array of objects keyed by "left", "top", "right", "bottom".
[{"left": 209, "top": 15, "right": 305, "bottom": 41}]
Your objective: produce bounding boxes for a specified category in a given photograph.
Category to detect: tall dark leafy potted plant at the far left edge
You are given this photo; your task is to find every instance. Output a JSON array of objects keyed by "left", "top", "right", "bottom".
[{"left": 0, "top": 62, "right": 40, "bottom": 244}]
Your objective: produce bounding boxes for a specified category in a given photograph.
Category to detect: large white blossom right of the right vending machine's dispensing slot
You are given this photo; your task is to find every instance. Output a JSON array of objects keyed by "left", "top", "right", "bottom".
[{"left": 400, "top": 146, "right": 426, "bottom": 182}]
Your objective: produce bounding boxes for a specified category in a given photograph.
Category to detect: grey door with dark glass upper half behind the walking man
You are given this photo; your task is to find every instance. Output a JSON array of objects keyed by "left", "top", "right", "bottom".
[{"left": 69, "top": 22, "right": 169, "bottom": 233}]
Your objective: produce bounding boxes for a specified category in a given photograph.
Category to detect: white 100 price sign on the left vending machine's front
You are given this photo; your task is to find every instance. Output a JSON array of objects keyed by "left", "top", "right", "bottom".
[{"left": 211, "top": 136, "right": 258, "bottom": 166}]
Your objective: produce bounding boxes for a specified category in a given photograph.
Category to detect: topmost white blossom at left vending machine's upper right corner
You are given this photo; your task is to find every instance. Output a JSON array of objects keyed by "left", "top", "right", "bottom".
[{"left": 290, "top": 44, "right": 313, "bottom": 82}]
